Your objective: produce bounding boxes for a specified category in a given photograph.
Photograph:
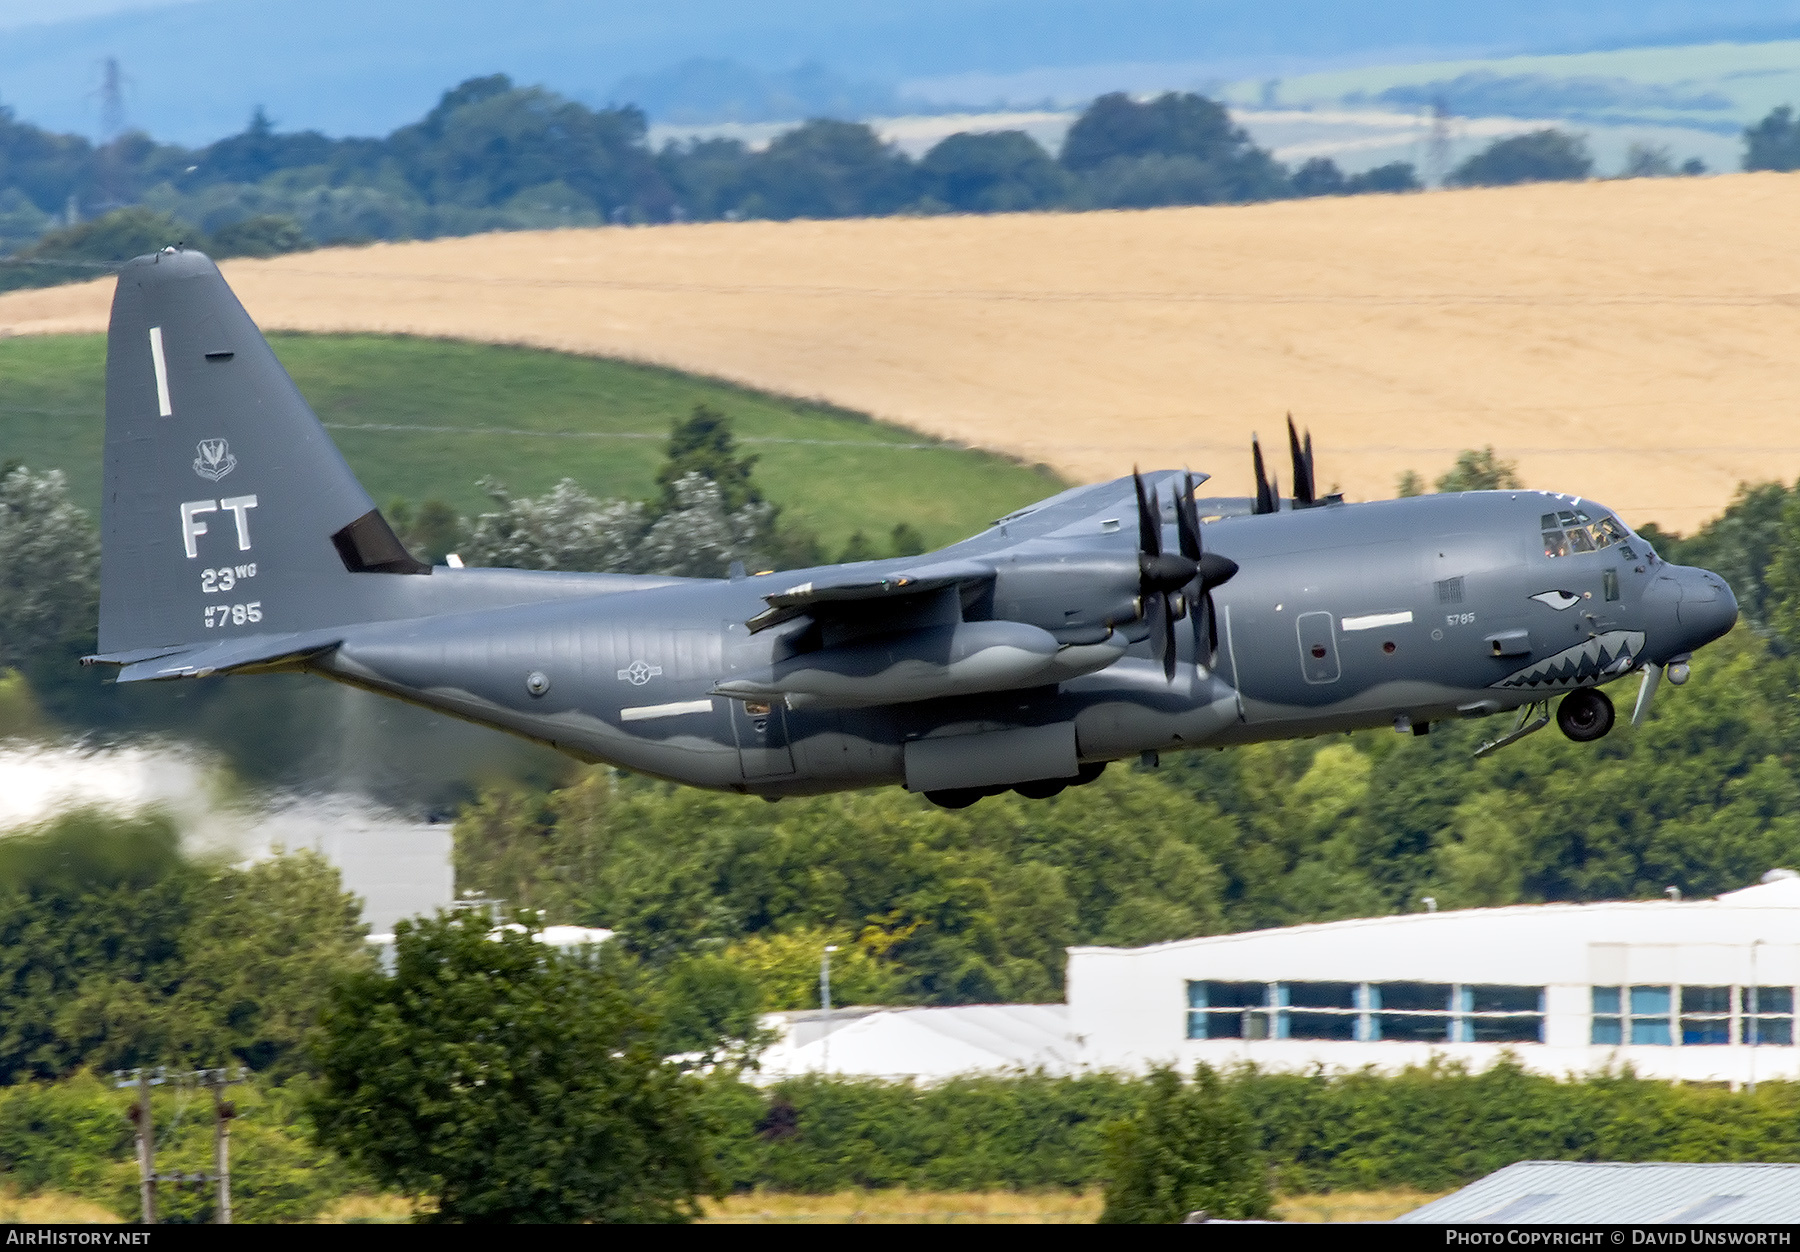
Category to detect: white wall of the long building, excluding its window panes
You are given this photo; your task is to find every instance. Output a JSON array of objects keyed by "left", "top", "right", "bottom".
[{"left": 1067, "top": 878, "right": 1800, "bottom": 1083}]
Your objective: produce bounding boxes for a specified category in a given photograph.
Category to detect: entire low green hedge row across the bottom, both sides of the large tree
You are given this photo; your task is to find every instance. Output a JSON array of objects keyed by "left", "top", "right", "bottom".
[{"left": 0, "top": 1063, "right": 1800, "bottom": 1221}]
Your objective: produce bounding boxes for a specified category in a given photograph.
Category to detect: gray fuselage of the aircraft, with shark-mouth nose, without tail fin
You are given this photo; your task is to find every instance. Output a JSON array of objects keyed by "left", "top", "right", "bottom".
[{"left": 308, "top": 480, "right": 1737, "bottom": 797}]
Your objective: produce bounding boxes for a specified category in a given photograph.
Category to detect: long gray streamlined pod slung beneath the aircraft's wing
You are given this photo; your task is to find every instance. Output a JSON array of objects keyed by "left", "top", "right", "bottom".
[{"left": 715, "top": 622, "right": 1129, "bottom": 709}]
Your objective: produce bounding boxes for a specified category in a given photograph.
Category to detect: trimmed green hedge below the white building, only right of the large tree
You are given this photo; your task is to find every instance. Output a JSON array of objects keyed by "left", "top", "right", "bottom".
[{"left": 711, "top": 1063, "right": 1800, "bottom": 1194}]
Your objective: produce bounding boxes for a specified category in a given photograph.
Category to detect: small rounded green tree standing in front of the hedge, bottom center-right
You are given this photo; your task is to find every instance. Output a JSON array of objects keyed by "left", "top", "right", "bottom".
[{"left": 1100, "top": 1065, "right": 1274, "bottom": 1223}]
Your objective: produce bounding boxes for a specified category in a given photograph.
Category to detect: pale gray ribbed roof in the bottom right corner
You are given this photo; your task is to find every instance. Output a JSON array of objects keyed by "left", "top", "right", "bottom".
[{"left": 1397, "top": 1160, "right": 1800, "bottom": 1225}]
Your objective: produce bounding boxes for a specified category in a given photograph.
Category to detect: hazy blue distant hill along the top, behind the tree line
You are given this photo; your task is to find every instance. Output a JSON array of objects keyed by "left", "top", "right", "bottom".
[{"left": 10, "top": 0, "right": 1800, "bottom": 144}]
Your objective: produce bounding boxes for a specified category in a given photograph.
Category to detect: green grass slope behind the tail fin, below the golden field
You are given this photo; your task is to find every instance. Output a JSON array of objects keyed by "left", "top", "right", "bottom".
[{"left": 0, "top": 335, "right": 1066, "bottom": 550}]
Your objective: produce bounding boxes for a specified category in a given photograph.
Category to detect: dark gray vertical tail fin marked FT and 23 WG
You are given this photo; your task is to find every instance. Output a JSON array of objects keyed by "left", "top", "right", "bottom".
[{"left": 99, "top": 248, "right": 430, "bottom": 655}]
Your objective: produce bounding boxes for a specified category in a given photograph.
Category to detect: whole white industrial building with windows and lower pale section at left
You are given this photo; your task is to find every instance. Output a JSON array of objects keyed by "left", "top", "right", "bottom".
[{"left": 763, "top": 871, "right": 1800, "bottom": 1087}]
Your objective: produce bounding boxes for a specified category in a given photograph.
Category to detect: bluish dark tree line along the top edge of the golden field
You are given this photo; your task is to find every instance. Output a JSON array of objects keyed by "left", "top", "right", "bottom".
[{"left": 10, "top": 74, "right": 1800, "bottom": 290}]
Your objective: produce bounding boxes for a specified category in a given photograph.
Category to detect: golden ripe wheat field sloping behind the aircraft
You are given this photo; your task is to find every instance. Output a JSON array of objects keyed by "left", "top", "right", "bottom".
[{"left": 10, "top": 174, "right": 1800, "bottom": 531}]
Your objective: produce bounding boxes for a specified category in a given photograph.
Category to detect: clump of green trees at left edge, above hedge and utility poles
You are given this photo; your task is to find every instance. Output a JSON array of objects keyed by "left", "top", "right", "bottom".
[{"left": 0, "top": 813, "right": 367, "bottom": 1083}]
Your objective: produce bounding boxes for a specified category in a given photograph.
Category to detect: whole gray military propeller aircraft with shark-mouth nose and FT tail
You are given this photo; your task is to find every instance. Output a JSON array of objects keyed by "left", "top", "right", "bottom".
[{"left": 86, "top": 248, "right": 1737, "bottom": 808}]
